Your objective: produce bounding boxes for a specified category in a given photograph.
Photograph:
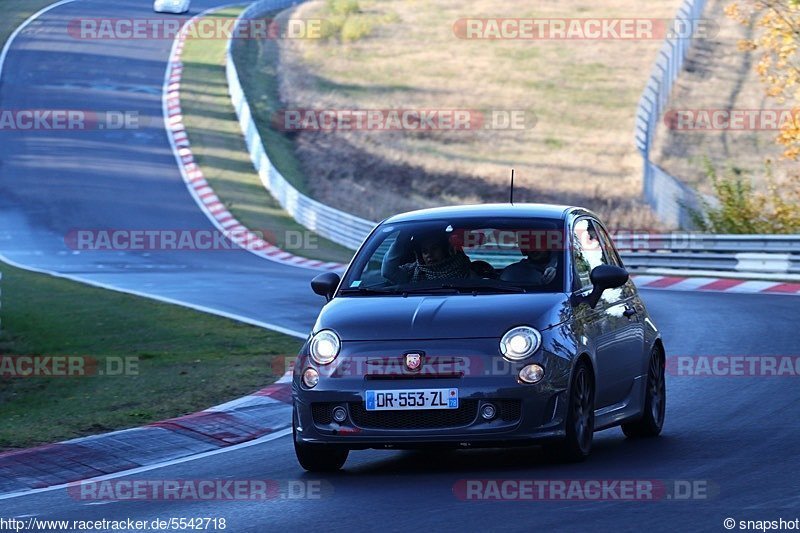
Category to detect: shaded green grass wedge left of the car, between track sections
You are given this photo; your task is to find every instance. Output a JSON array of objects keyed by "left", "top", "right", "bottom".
[{"left": 0, "top": 263, "right": 301, "bottom": 449}]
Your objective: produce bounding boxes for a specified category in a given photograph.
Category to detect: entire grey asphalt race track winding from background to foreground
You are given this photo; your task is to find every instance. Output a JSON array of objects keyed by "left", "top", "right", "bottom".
[{"left": 0, "top": 0, "right": 800, "bottom": 532}]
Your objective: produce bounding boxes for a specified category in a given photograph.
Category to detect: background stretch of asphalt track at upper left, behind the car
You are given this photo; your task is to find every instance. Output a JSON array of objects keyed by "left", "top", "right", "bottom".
[{"left": 0, "top": 0, "right": 321, "bottom": 336}]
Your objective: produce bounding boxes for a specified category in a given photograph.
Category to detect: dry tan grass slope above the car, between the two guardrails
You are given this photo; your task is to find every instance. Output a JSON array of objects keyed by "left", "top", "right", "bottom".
[{"left": 272, "top": 0, "right": 680, "bottom": 227}]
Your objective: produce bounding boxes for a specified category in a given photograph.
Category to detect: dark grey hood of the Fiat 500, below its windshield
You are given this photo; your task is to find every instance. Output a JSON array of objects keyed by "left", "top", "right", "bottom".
[{"left": 314, "top": 293, "right": 569, "bottom": 341}]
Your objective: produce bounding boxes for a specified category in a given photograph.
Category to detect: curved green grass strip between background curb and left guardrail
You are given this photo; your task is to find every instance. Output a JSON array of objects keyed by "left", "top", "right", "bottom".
[{"left": 181, "top": 8, "right": 352, "bottom": 263}]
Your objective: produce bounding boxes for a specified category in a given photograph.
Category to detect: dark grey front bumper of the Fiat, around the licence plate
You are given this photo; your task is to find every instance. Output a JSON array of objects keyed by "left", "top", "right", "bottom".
[{"left": 292, "top": 339, "right": 571, "bottom": 449}]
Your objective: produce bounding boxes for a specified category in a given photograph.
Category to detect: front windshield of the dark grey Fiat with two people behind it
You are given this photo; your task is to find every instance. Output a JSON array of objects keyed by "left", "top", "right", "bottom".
[{"left": 340, "top": 217, "right": 565, "bottom": 296}]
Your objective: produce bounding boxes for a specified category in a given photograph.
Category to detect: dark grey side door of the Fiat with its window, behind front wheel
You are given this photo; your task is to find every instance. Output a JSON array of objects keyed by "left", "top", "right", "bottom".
[{"left": 571, "top": 216, "right": 643, "bottom": 409}]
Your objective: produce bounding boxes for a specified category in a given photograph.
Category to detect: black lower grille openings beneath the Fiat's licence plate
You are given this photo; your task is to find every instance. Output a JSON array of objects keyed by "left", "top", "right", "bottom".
[{"left": 311, "top": 400, "right": 522, "bottom": 429}]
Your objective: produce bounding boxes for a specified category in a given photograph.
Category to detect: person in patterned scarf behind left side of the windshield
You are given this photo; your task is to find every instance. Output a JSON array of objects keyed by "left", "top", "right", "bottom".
[{"left": 381, "top": 233, "right": 472, "bottom": 284}]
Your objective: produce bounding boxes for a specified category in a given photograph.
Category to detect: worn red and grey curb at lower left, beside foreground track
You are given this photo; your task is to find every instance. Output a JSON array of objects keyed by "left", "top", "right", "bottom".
[{"left": 0, "top": 373, "right": 292, "bottom": 500}]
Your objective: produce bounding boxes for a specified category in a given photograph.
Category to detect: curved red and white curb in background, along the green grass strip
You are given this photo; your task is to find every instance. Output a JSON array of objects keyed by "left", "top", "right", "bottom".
[{"left": 163, "top": 8, "right": 346, "bottom": 271}]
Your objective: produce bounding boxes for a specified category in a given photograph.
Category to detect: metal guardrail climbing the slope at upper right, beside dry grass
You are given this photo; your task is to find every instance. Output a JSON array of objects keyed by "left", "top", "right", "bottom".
[{"left": 634, "top": 0, "right": 706, "bottom": 228}]
